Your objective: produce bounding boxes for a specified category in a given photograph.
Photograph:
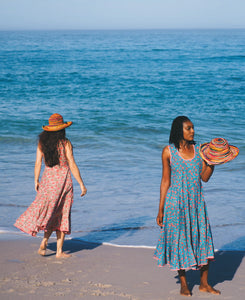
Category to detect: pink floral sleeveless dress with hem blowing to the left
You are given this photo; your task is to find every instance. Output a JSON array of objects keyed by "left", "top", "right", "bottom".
[{"left": 14, "top": 141, "right": 73, "bottom": 236}]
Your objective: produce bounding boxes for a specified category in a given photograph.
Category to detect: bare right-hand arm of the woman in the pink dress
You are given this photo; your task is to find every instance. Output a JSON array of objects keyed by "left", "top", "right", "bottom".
[{"left": 65, "top": 141, "right": 87, "bottom": 197}]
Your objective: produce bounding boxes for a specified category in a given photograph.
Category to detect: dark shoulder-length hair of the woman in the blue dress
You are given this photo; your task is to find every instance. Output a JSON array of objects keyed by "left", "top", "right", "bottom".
[{"left": 169, "top": 116, "right": 196, "bottom": 150}]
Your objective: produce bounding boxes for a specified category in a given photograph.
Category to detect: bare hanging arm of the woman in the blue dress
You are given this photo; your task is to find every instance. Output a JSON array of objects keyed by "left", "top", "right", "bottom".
[{"left": 156, "top": 147, "right": 171, "bottom": 226}]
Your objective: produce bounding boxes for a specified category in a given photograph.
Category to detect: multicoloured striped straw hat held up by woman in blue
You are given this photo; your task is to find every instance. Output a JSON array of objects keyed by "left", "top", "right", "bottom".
[{"left": 200, "top": 138, "right": 239, "bottom": 165}]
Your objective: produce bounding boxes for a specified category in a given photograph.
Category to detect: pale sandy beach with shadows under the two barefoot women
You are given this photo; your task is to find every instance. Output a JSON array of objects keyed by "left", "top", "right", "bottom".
[{"left": 0, "top": 238, "right": 245, "bottom": 300}]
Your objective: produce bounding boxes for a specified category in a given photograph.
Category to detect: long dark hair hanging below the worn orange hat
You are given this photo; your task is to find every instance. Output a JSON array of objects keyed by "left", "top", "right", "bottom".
[{"left": 39, "top": 129, "right": 66, "bottom": 167}]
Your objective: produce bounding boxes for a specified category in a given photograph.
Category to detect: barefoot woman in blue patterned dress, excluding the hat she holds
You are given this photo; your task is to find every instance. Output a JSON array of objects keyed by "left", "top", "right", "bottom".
[{"left": 155, "top": 116, "right": 220, "bottom": 296}]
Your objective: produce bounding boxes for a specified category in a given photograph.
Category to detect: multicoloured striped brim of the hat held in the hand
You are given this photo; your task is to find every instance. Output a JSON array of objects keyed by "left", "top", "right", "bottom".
[{"left": 199, "top": 143, "right": 239, "bottom": 165}]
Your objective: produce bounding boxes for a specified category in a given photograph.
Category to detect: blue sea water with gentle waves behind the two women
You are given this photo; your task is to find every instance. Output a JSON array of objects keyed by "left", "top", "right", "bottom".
[{"left": 0, "top": 30, "right": 245, "bottom": 250}]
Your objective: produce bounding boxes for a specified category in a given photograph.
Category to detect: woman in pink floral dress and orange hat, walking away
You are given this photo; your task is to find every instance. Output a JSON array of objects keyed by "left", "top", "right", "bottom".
[{"left": 14, "top": 114, "right": 87, "bottom": 258}]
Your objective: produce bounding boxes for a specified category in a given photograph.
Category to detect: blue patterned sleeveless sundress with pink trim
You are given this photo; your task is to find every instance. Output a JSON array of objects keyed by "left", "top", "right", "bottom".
[{"left": 154, "top": 145, "right": 214, "bottom": 270}]
